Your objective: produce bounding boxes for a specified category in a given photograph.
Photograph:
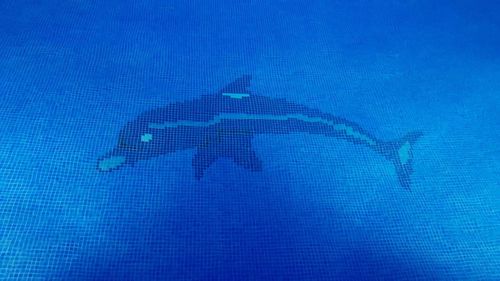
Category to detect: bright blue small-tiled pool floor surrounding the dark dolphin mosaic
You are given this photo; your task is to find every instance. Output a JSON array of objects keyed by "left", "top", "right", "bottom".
[{"left": 0, "top": 0, "right": 500, "bottom": 281}]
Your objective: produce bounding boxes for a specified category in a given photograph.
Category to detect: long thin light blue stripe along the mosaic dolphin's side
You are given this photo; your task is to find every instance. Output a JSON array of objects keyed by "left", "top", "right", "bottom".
[{"left": 148, "top": 113, "right": 377, "bottom": 145}]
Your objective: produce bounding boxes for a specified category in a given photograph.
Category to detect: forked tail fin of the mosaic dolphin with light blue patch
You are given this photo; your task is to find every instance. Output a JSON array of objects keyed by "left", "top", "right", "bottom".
[{"left": 379, "top": 132, "right": 423, "bottom": 190}]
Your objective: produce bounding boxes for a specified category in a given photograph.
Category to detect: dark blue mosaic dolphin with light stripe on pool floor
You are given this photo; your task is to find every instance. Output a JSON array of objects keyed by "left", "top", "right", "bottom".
[{"left": 97, "top": 75, "right": 423, "bottom": 189}]
